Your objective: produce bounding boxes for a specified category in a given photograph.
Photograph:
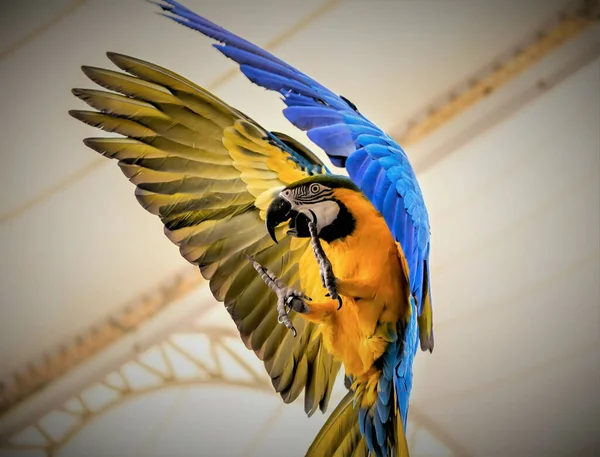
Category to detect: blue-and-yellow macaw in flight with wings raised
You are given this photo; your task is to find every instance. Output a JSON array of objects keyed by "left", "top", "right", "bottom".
[{"left": 70, "top": 0, "right": 434, "bottom": 457}]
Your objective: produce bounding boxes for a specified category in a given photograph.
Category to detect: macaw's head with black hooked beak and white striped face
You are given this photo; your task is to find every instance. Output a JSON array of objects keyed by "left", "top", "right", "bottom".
[{"left": 266, "top": 175, "right": 360, "bottom": 242}]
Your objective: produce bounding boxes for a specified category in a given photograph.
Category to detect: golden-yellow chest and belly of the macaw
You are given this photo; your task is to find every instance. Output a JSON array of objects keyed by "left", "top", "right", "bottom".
[{"left": 300, "top": 190, "right": 408, "bottom": 377}]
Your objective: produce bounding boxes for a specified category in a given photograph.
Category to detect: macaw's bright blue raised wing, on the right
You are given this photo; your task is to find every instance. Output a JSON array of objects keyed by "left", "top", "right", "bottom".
[{"left": 157, "top": 0, "right": 433, "bottom": 351}]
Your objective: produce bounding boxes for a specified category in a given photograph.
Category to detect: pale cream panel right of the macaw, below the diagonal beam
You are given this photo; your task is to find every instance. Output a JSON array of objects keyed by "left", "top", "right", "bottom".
[{"left": 414, "top": 56, "right": 600, "bottom": 457}]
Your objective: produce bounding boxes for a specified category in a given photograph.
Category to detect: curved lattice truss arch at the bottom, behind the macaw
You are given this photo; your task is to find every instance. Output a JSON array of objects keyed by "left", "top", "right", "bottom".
[{"left": 0, "top": 325, "right": 465, "bottom": 457}]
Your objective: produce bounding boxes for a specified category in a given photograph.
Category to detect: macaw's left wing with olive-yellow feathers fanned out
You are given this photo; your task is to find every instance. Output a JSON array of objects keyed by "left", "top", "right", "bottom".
[{"left": 70, "top": 53, "right": 340, "bottom": 415}]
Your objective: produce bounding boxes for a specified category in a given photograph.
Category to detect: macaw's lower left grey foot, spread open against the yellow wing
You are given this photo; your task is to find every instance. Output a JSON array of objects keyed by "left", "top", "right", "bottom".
[{"left": 248, "top": 256, "right": 312, "bottom": 337}]
